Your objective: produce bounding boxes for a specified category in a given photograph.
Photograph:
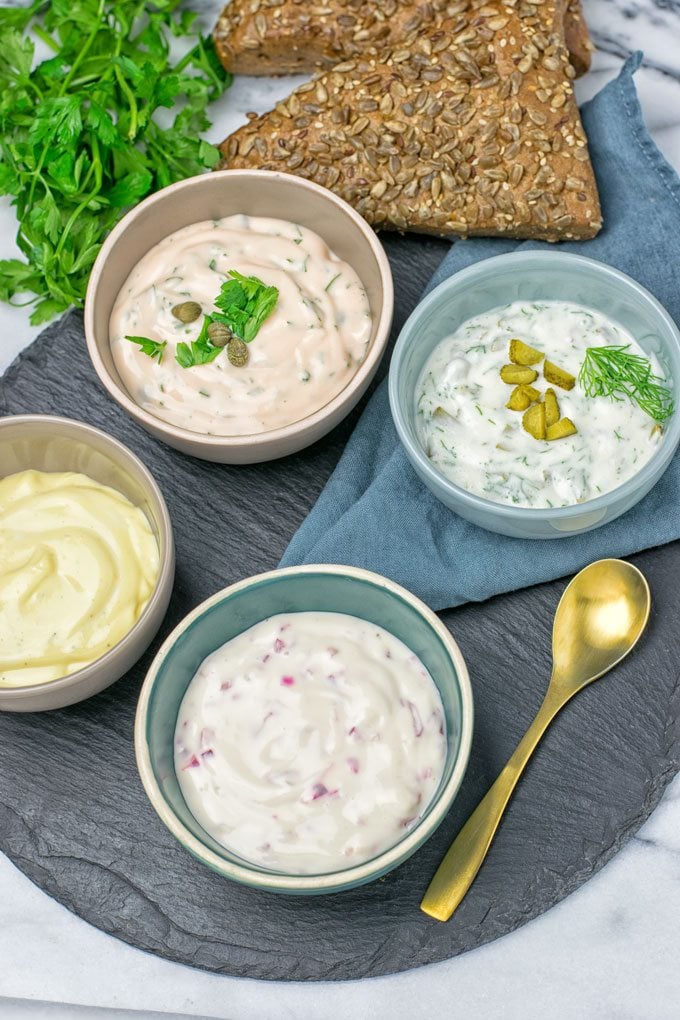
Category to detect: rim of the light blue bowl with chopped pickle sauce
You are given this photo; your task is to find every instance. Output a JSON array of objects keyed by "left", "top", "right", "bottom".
[{"left": 387, "top": 248, "right": 680, "bottom": 518}]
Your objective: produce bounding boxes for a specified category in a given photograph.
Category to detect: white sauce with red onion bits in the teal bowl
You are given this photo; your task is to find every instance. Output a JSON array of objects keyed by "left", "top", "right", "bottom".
[{"left": 175, "top": 612, "right": 447, "bottom": 874}]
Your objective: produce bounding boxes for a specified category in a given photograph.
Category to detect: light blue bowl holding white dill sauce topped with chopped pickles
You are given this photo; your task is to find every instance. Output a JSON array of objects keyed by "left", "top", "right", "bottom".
[{"left": 389, "top": 251, "right": 680, "bottom": 539}]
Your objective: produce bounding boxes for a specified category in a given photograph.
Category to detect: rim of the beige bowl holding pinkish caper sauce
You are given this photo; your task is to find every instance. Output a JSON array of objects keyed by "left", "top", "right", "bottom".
[{"left": 85, "top": 169, "right": 395, "bottom": 450}]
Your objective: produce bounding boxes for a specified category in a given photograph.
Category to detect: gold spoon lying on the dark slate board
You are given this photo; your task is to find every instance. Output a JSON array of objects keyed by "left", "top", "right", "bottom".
[{"left": 420, "top": 560, "right": 650, "bottom": 921}]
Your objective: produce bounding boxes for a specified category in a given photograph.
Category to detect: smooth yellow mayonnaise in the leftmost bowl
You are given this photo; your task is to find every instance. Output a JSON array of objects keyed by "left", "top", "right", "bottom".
[{"left": 0, "top": 471, "right": 159, "bottom": 687}]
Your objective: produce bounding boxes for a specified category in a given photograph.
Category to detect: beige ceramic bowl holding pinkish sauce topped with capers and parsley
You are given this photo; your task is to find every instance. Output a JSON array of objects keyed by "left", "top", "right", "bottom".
[{"left": 85, "top": 170, "right": 394, "bottom": 464}]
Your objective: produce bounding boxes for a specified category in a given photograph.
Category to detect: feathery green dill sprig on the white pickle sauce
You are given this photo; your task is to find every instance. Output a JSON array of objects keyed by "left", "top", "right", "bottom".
[{"left": 578, "top": 344, "right": 674, "bottom": 424}]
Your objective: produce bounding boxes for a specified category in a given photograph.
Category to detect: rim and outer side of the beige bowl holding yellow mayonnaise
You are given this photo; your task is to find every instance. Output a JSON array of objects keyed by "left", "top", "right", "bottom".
[{"left": 0, "top": 414, "right": 174, "bottom": 704}]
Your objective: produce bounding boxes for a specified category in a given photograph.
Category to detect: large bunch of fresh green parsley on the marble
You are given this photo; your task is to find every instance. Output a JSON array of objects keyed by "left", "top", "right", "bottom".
[{"left": 0, "top": 0, "right": 231, "bottom": 323}]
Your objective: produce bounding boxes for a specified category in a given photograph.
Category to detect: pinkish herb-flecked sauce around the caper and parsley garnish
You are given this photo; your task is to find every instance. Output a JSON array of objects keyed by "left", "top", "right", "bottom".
[{"left": 109, "top": 215, "right": 371, "bottom": 436}]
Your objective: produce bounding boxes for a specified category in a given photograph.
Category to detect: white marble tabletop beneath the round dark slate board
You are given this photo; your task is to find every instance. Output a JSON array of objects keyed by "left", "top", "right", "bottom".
[{"left": 0, "top": 0, "right": 680, "bottom": 1020}]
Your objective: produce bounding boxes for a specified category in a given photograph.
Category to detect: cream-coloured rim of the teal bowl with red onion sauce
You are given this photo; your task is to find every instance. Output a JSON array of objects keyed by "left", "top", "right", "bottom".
[{"left": 135, "top": 563, "right": 474, "bottom": 894}]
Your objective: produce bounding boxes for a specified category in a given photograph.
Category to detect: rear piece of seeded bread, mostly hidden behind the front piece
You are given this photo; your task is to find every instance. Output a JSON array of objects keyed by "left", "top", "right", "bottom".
[{"left": 214, "top": 0, "right": 591, "bottom": 74}]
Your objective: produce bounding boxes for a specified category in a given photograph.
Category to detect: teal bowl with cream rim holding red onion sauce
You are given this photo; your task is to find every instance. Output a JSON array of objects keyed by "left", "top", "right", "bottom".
[{"left": 135, "top": 565, "right": 473, "bottom": 894}]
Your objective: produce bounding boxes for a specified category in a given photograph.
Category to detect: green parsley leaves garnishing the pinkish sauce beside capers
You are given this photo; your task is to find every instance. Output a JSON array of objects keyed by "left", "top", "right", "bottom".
[{"left": 125, "top": 269, "right": 278, "bottom": 368}]
